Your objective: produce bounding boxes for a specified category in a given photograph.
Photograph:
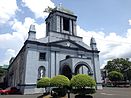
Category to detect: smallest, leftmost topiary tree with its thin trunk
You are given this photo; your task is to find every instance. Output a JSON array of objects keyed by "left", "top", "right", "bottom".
[{"left": 37, "top": 77, "right": 50, "bottom": 93}]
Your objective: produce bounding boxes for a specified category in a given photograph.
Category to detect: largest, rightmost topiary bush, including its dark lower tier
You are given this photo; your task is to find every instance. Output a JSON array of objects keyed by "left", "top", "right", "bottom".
[{"left": 70, "top": 74, "right": 96, "bottom": 95}]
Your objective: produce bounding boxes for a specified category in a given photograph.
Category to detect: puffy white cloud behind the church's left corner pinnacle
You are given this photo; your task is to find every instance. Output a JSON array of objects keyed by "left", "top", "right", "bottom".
[{"left": 12, "top": 17, "right": 46, "bottom": 41}]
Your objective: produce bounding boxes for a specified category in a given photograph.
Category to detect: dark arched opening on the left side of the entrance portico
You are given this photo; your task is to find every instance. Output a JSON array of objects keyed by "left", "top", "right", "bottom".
[{"left": 61, "top": 65, "right": 72, "bottom": 80}]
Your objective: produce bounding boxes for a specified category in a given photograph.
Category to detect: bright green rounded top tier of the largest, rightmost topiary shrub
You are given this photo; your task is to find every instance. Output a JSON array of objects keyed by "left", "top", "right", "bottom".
[{"left": 70, "top": 74, "right": 96, "bottom": 88}]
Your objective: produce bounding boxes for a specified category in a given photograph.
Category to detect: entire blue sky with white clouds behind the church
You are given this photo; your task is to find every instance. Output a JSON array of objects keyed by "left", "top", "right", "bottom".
[{"left": 0, "top": 0, "right": 131, "bottom": 68}]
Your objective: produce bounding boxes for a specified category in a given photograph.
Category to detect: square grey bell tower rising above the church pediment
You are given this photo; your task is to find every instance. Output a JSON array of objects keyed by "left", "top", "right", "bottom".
[{"left": 45, "top": 6, "right": 78, "bottom": 39}]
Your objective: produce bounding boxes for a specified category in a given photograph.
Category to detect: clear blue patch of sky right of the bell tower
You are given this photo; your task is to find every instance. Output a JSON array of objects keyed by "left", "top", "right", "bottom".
[{"left": 53, "top": 0, "right": 131, "bottom": 34}]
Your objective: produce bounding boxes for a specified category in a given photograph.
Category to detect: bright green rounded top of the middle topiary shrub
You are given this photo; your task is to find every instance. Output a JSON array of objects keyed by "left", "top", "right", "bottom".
[{"left": 50, "top": 75, "right": 70, "bottom": 88}]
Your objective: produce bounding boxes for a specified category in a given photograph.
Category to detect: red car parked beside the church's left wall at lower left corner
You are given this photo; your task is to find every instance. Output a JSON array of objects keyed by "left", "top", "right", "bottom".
[{"left": 0, "top": 87, "right": 19, "bottom": 95}]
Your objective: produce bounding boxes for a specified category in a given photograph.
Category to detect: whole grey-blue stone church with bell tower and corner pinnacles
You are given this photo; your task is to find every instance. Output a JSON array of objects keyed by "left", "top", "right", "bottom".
[{"left": 5, "top": 6, "right": 102, "bottom": 94}]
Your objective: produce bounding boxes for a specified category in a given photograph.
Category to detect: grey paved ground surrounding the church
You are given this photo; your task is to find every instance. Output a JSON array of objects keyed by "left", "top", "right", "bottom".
[{"left": 0, "top": 87, "right": 131, "bottom": 98}]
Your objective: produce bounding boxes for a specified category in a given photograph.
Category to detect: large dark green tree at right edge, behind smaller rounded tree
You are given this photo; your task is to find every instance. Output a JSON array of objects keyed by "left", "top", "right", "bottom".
[{"left": 104, "top": 58, "right": 131, "bottom": 80}]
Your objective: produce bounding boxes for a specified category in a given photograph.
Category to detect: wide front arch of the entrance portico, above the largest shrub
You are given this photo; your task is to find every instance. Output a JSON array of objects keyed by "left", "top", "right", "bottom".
[{"left": 75, "top": 62, "right": 93, "bottom": 75}]
